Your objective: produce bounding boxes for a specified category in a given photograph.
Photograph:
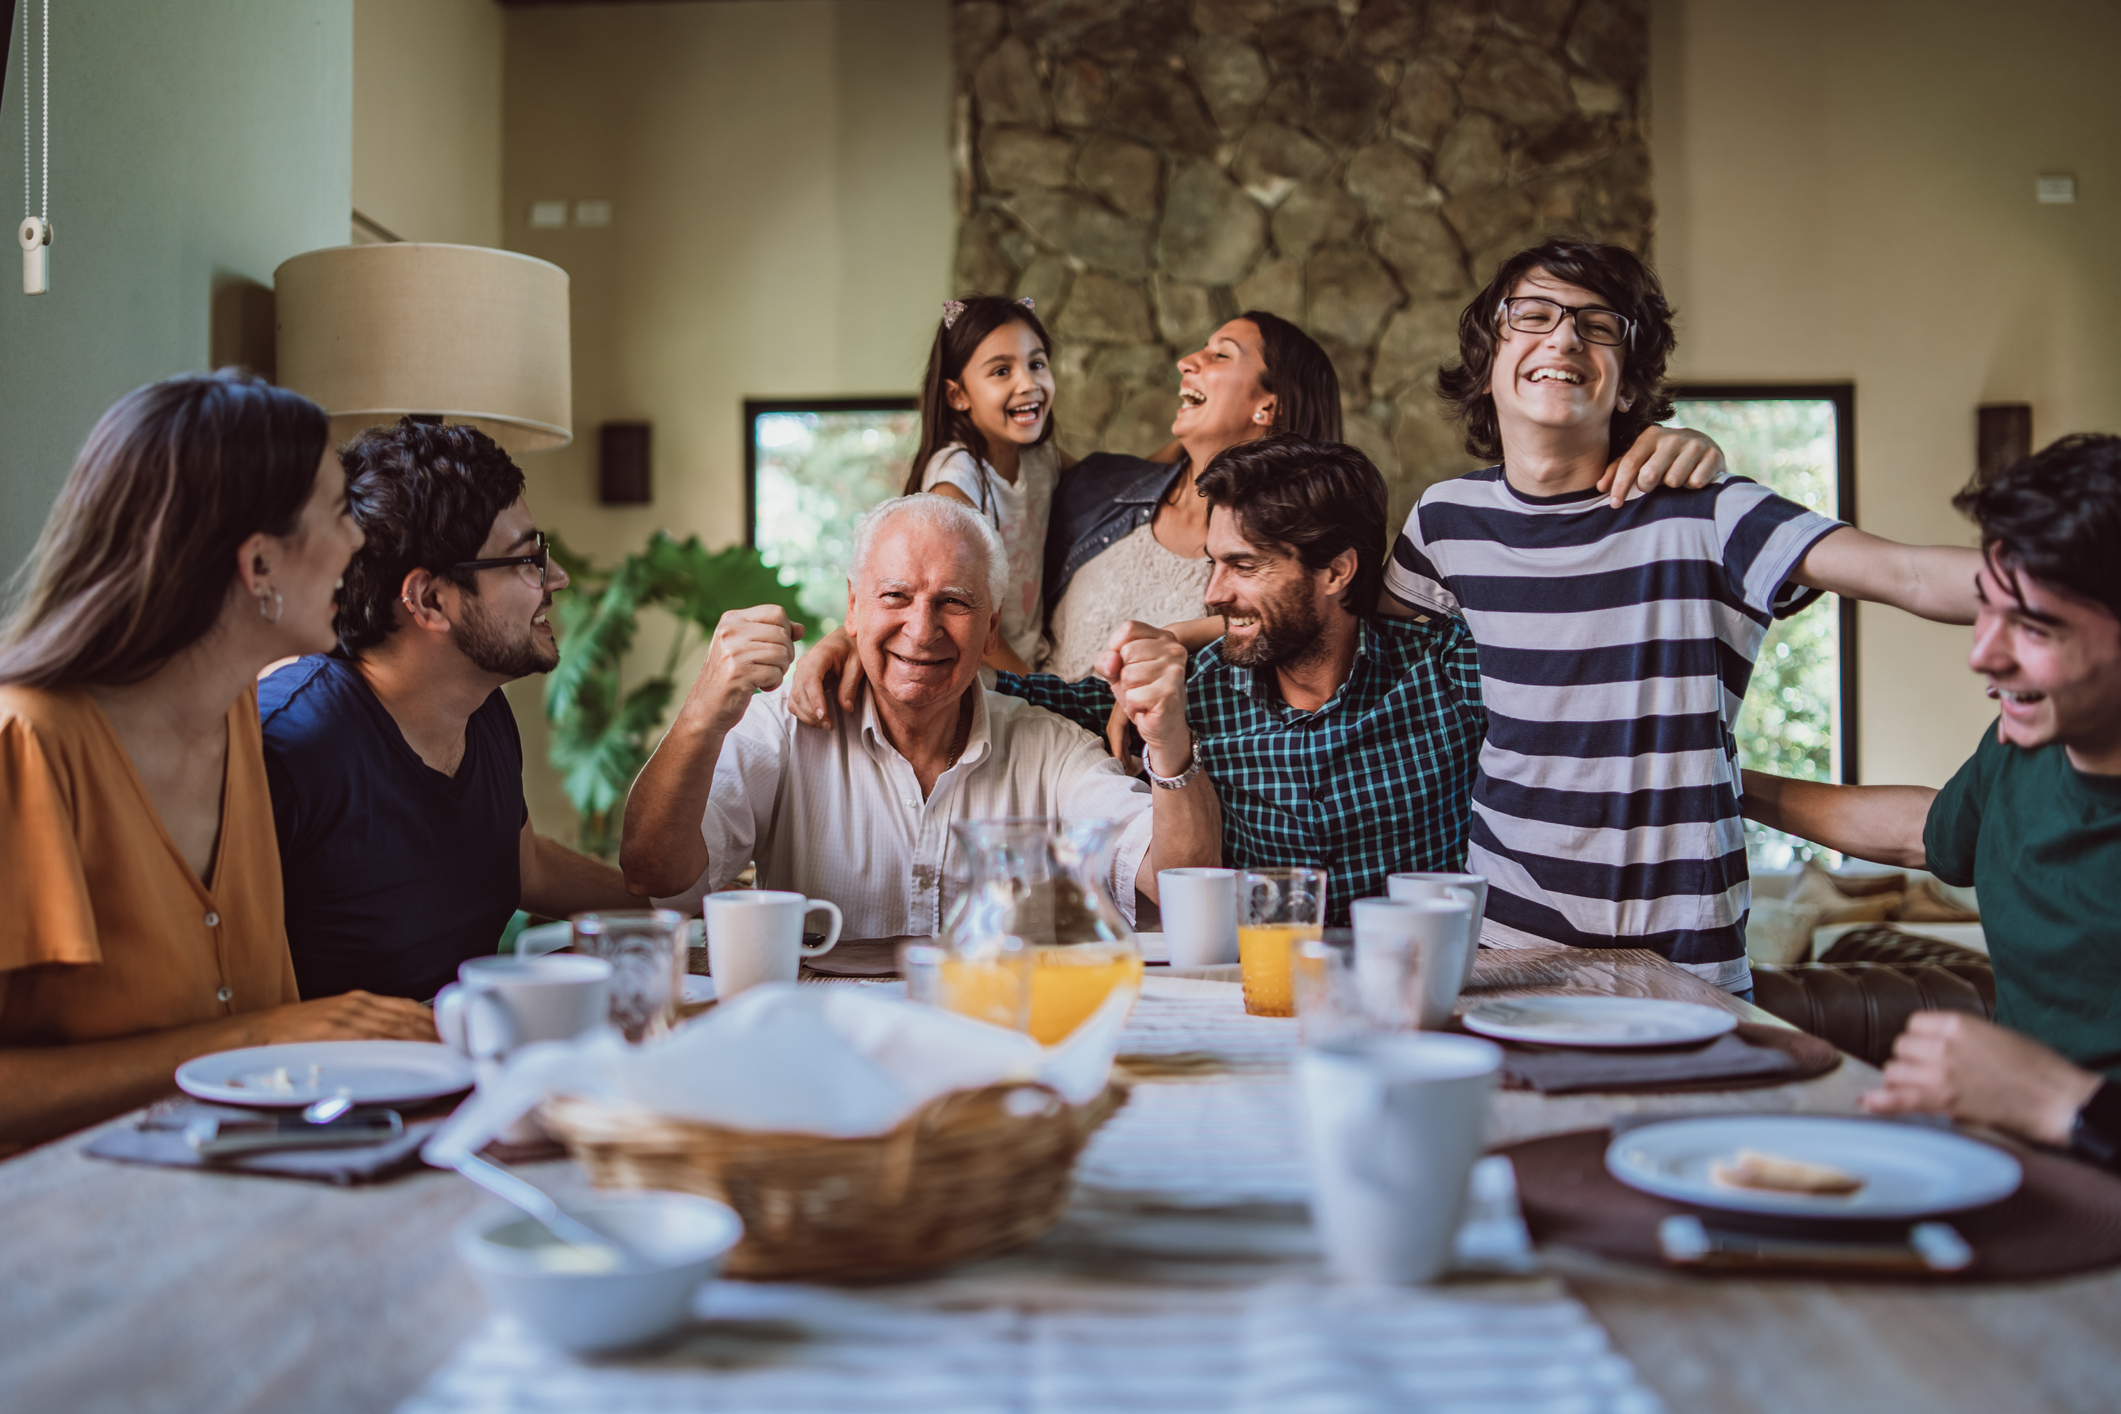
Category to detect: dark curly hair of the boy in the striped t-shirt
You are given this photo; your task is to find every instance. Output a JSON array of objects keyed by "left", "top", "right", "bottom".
[{"left": 1436, "top": 240, "right": 1678, "bottom": 462}]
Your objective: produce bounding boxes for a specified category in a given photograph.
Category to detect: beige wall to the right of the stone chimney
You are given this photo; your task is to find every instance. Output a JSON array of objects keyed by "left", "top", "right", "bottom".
[{"left": 1652, "top": 0, "right": 2121, "bottom": 784}]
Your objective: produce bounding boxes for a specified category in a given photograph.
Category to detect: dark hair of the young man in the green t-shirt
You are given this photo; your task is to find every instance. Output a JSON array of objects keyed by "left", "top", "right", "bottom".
[{"left": 1951, "top": 432, "right": 2121, "bottom": 619}]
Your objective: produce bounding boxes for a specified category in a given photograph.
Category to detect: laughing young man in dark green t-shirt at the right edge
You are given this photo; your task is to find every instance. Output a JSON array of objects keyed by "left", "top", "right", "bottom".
[{"left": 1746, "top": 435, "right": 2121, "bottom": 1164}]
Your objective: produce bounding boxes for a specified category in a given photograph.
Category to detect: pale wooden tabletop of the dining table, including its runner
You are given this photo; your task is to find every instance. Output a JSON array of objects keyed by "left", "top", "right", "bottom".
[{"left": 0, "top": 945, "right": 2121, "bottom": 1414}]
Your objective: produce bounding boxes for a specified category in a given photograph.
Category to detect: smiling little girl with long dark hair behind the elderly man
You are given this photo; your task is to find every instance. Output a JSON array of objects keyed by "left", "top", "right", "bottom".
[{"left": 906, "top": 295, "right": 1063, "bottom": 672}]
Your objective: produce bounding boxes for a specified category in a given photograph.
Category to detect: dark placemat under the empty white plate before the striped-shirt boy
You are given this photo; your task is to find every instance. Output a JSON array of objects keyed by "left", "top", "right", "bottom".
[{"left": 1502, "top": 1022, "right": 1841, "bottom": 1094}]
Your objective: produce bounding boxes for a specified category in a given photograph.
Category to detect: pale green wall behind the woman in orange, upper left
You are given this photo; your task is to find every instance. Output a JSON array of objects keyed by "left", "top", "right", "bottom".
[{"left": 0, "top": 0, "right": 354, "bottom": 575}]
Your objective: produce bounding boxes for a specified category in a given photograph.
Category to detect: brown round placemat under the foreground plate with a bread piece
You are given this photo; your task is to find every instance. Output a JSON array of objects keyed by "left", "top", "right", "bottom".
[{"left": 1497, "top": 1130, "right": 2121, "bottom": 1283}]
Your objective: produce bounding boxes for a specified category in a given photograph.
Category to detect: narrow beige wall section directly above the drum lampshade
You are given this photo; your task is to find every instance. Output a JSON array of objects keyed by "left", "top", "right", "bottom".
[{"left": 354, "top": 0, "right": 503, "bottom": 246}]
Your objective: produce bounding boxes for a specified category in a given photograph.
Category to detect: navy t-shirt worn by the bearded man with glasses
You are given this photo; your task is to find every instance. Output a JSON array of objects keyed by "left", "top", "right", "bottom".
[{"left": 259, "top": 657, "right": 530, "bottom": 1001}]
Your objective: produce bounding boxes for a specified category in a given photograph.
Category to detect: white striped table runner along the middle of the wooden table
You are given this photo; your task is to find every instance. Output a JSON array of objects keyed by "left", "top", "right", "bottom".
[{"left": 401, "top": 977, "right": 1661, "bottom": 1414}]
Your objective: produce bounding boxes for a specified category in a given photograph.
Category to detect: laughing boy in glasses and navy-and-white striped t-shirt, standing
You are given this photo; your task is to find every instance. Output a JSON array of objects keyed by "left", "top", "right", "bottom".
[{"left": 1385, "top": 240, "right": 1979, "bottom": 992}]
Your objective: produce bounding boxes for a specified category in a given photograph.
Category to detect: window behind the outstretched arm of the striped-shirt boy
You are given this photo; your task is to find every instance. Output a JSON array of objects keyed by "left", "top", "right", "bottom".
[{"left": 1671, "top": 384, "right": 1856, "bottom": 869}]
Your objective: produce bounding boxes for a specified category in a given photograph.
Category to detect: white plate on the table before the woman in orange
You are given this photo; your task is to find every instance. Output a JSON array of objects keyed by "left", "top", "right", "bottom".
[{"left": 176, "top": 1041, "right": 477, "bottom": 1107}]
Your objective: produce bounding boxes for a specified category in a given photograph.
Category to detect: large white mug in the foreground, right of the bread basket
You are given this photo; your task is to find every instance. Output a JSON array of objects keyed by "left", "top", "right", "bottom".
[{"left": 1296, "top": 1032, "right": 1502, "bottom": 1285}]
